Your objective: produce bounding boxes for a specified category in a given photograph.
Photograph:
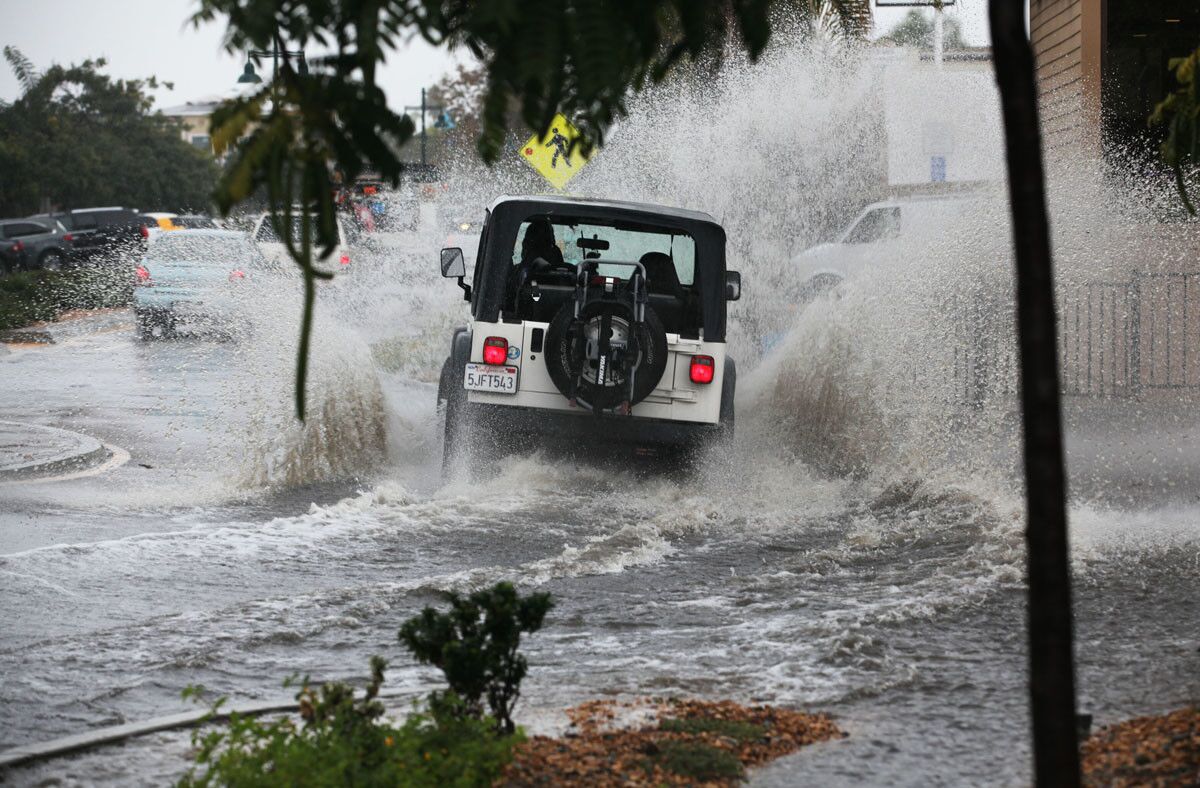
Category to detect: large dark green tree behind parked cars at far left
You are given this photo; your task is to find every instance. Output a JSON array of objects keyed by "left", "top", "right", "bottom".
[{"left": 0, "top": 47, "right": 216, "bottom": 216}]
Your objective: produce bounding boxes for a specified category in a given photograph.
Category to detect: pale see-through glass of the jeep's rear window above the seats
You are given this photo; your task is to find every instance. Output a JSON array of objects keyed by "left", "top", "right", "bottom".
[{"left": 512, "top": 217, "right": 696, "bottom": 285}]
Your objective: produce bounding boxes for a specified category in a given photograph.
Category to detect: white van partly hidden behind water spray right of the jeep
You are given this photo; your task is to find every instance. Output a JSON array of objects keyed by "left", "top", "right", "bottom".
[{"left": 792, "top": 193, "right": 976, "bottom": 302}]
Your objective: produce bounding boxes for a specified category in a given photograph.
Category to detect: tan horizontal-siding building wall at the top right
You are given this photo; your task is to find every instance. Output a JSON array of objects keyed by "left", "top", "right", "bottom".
[{"left": 1030, "top": 0, "right": 1104, "bottom": 151}]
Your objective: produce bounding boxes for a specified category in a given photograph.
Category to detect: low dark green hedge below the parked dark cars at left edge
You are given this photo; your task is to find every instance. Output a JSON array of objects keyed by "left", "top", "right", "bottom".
[{"left": 0, "top": 264, "right": 133, "bottom": 330}]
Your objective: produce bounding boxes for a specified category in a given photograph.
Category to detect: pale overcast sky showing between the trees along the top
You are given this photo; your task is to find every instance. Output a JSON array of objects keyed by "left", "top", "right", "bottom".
[{"left": 0, "top": 0, "right": 988, "bottom": 107}]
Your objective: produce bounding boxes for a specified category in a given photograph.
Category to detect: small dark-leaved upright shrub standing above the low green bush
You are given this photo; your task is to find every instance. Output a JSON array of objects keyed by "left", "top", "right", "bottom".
[{"left": 400, "top": 583, "right": 553, "bottom": 733}]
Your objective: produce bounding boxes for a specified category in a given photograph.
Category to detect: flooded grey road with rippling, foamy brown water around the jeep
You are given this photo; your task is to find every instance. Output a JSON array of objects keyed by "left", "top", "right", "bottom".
[{"left": 0, "top": 299, "right": 1200, "bottom": 786}]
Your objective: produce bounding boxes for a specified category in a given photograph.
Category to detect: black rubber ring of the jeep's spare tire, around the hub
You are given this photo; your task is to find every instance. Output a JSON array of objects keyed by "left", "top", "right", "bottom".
[{"left": 545, "top": 300, "right": 667, "bottom": 410}]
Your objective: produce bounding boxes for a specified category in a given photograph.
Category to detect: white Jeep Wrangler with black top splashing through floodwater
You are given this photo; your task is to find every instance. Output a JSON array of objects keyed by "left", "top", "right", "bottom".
[{"left": 438, "top": 197, "right": 742, "bottom": 467}]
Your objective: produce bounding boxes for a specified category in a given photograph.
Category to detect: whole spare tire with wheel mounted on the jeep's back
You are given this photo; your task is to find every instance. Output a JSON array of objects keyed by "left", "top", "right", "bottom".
[{"left": 545, "top": 300, "right": 667, "bottom": 411}]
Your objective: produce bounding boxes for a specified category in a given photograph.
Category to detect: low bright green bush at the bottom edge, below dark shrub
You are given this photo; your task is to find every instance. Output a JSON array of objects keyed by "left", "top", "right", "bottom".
[{"left": 179, "top": 657, "right": 522, "bottom": 788}]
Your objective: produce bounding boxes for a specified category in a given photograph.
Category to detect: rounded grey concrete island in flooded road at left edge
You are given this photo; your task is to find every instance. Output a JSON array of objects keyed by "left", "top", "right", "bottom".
[{"left": 0, "top": 421, "right": 112, "bottom": 482}]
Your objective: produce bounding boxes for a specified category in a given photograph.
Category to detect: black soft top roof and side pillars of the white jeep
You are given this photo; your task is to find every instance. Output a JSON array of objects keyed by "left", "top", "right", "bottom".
[{"left": 472, "top": 196, "right": 725, "bottom": 342}]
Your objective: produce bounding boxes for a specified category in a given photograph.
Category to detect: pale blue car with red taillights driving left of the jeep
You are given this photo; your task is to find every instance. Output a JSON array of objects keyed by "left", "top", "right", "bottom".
[{"left": 133, "top": 230, "right": 274, "bottom": 339}]
